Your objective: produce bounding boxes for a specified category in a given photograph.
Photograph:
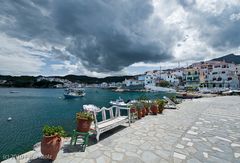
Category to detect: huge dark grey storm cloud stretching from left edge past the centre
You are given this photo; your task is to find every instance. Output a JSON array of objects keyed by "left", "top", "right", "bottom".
[{"left": 0, "top": 0, "right": 175, "bottom": 72}]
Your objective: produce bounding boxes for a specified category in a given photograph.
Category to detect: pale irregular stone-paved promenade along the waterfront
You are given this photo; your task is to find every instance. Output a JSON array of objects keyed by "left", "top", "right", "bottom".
[{"left": 4, "top": 96, "right": 240, "bottom": 163}]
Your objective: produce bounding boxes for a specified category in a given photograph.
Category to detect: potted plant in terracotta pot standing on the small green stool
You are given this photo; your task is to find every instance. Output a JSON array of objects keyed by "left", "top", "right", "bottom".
[{"left": 76, "top": 112, "right": 94, "bottom": 132}]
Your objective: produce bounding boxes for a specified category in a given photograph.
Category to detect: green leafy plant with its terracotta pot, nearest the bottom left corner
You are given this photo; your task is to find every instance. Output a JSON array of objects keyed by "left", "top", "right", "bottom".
[{"left": 41, "top": 125, "right": 65, "bottom": 160}]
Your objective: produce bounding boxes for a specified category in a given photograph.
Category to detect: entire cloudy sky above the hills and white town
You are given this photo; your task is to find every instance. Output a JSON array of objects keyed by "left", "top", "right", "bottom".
[{"left": 0, "top": 0, "right": 240, "bottom": 77}]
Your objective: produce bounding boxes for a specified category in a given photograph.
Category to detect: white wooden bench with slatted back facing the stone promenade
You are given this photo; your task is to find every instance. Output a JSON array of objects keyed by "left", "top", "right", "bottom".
[{"left": 83, "top": 105, "right": 130, "bottom": 141}]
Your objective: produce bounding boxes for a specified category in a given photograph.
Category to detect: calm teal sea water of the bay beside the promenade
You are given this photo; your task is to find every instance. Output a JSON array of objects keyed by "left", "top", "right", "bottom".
[{"left": 0, "top": 88, "right": 173, "bottom": 160}]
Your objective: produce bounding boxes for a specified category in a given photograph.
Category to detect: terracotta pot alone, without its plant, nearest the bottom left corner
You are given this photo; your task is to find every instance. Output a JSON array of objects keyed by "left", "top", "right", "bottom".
[{"left": 41, "top": 135, "right": 61, "bottom": 160}]
